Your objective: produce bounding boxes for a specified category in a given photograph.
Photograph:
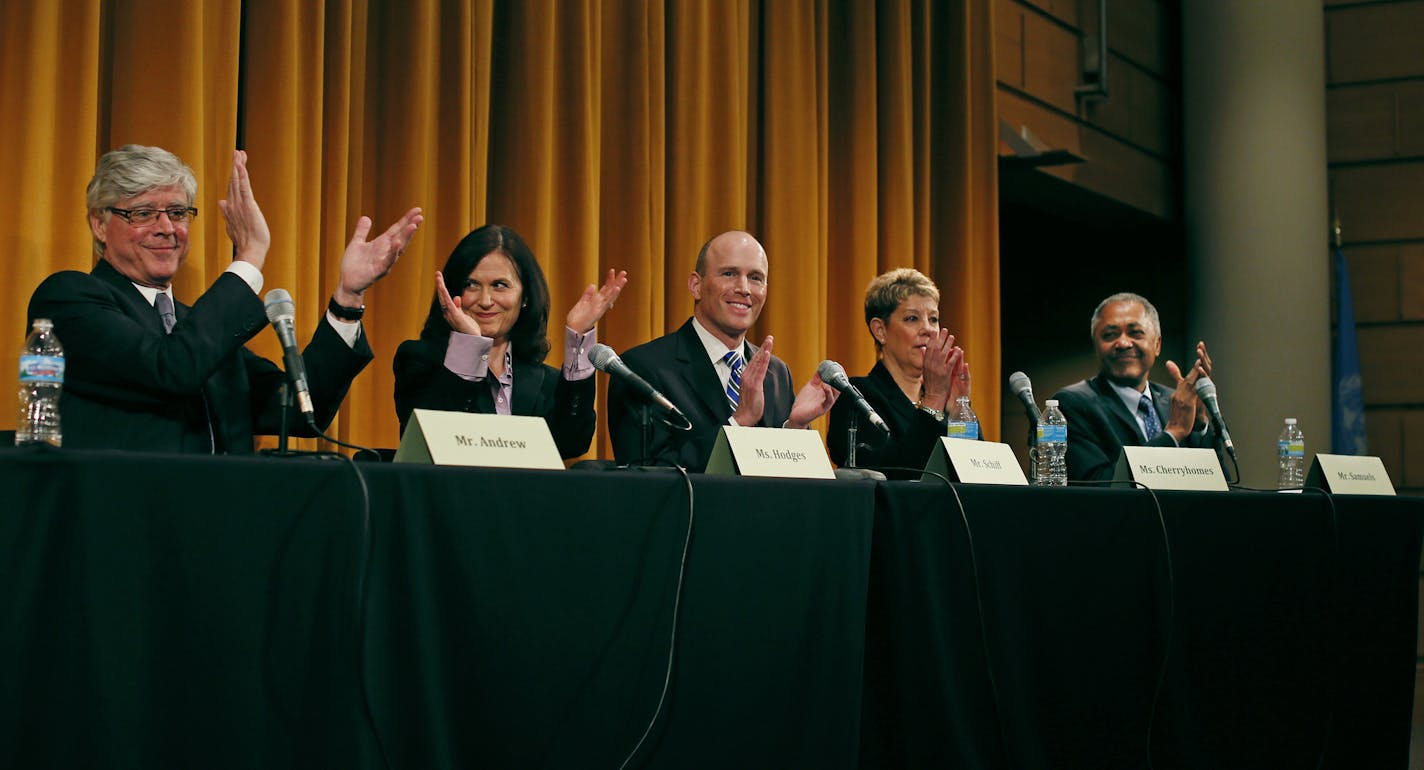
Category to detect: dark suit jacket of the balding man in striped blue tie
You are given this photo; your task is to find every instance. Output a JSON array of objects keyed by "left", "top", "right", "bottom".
[{"left": 608, "top": 319, "right": 796, "bottom": 473}]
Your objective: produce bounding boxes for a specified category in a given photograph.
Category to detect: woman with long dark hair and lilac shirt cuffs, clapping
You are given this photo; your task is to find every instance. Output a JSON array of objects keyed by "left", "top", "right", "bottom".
[{"left": 394, "top": 225, "right": 628, "bottom": 458}]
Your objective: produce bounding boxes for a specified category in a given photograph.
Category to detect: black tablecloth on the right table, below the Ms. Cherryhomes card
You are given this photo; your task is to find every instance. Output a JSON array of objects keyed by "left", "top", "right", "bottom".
[{"left": 862, "top": 482, "right": 1421, "bottom": 769}]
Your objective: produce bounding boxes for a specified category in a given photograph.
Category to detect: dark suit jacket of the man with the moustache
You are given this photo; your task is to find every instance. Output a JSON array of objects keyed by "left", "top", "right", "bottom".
[{"left": 1054, "top": 374, "right": 1216, "bottom": 481}]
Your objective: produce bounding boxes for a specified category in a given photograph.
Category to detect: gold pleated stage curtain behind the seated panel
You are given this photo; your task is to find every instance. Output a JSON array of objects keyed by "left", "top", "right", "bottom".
[{"left": 0, "top": 0, "right": 1001, "bottom": 457}]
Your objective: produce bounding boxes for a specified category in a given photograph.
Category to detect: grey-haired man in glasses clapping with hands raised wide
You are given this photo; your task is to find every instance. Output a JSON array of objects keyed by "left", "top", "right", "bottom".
[{"left": 28, "top": 145, "right": 422, "bottom": 454}]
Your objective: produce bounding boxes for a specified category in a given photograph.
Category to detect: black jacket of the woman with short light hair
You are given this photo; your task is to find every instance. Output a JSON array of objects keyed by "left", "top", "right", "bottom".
[{"left": 826, "top": 363, "right": 944, "bottom": 478}]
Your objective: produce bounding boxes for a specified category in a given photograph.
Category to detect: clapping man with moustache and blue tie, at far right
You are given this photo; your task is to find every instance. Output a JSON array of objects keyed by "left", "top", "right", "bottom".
[{"left": 1054, "top": 292, "right": 1215, "bottom": 481}]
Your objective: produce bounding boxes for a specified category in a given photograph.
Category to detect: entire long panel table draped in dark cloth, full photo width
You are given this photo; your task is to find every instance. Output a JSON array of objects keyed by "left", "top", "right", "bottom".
[{"left": 0, "top": 450, "right": 1424, "bottom": 769}]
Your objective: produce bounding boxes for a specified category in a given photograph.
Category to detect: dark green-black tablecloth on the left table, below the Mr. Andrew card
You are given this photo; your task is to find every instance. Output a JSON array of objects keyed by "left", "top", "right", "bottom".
[{"left": 0, "top": 451, "right": 873, "bottom": 767}]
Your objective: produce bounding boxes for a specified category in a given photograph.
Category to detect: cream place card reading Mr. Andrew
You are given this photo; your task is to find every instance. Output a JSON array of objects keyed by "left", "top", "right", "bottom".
[{"left": 394, "top": 408, "right": 564, "bottom": 471}]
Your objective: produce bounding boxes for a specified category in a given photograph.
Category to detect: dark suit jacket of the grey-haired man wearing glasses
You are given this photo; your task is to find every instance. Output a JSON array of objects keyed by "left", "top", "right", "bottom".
[{"left": 30, "top": 259, "right": 372, "bottom": 454}]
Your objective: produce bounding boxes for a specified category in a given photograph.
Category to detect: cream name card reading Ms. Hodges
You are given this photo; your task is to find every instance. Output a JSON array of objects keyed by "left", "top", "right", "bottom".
[{"left": 706, "top": 426, "right": 836, "bottom": 478}]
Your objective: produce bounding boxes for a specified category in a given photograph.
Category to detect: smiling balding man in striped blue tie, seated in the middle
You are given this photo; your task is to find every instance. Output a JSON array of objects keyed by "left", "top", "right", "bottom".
[{"left": 608, "top": 231, "right": 836, "bottom": 473}]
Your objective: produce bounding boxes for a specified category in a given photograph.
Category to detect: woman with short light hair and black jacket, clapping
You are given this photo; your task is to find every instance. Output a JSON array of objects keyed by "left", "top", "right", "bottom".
[{"left": 826, "top": 268, "right": 970, "bottom": 478}]
